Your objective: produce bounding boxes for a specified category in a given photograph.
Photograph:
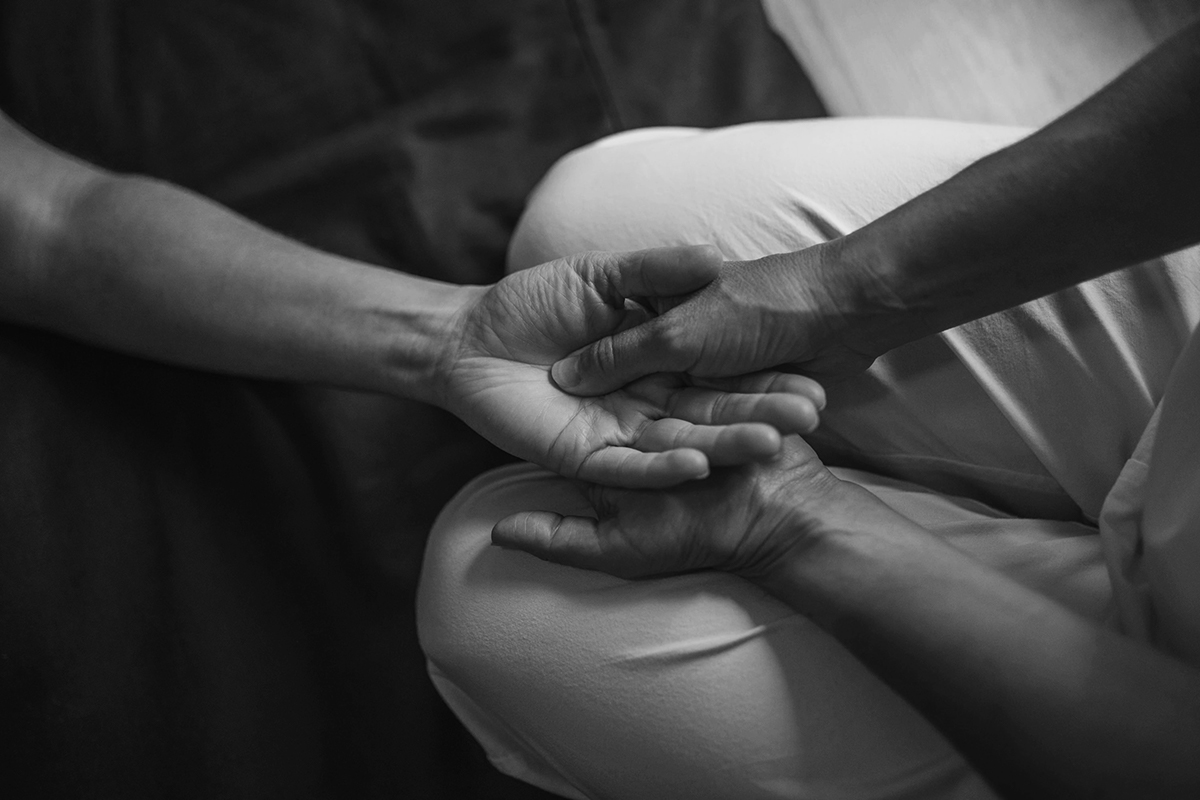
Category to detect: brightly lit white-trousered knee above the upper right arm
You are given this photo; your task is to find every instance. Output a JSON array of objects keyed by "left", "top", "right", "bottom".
[{"left": 509, "top": 119, "right": 1025, "bottom": 271}]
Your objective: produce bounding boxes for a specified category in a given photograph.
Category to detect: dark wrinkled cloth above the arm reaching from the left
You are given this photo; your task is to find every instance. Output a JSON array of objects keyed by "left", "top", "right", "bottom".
[{"left": 0, "top": 0, "right": 823, "bottom": 283}]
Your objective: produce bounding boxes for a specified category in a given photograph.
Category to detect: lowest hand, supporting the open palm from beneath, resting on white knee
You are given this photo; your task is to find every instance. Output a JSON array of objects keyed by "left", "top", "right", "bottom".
[{"left": 492, "top": 437, "right": 854, "bottom": 578}]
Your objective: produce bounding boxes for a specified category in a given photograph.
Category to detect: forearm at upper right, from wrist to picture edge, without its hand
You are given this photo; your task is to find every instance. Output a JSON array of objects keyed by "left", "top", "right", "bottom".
[{"left": 838, "top": 17, "right": 1200, "bottom": 349}]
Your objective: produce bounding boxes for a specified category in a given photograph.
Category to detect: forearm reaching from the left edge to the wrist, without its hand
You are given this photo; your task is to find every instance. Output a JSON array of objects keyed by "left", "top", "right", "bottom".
[{"left": 0, "top": 113, "right": 478, "bottom": 401}]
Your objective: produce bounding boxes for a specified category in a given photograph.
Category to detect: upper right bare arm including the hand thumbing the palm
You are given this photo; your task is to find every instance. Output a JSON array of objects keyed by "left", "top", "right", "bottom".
[{"left": 553, "top": 22, "right": 1200, "bottom": 393}]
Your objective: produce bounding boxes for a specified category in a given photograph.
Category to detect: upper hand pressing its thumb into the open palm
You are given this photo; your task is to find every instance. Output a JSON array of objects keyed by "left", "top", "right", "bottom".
[{"left": 553, "top": 240, "right": 888, "bottom": 395}]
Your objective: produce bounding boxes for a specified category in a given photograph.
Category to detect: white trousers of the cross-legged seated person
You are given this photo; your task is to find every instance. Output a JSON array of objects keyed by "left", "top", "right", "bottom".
[{"left": 418, "top": 120, "right": 1200, "bottom": 798}]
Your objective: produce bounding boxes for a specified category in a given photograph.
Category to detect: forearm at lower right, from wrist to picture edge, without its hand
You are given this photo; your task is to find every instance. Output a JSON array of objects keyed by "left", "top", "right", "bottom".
[{"left": 762, "top": 485, "right": 1200, "bottom": 798}]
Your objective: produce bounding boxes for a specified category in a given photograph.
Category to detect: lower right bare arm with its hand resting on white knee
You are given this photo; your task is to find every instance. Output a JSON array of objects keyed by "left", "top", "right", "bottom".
[{"left": 492, "top": 438, "right": 1200, "bottom": 799}]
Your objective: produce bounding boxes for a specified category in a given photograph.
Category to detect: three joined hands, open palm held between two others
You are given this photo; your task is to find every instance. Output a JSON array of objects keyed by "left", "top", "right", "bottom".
[{"left": 439, "top": 247, "right": 871, "bottom": 577}]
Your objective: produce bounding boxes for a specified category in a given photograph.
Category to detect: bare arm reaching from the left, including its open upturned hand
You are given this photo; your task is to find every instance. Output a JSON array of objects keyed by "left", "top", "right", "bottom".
[{"left": 0, "top": 115, "right": 822, "bottom": 486}]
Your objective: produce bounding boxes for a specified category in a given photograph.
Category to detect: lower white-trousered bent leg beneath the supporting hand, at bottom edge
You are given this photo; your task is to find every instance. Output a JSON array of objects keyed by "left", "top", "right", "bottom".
[{"left": 418, "top": 465, "right": 991, "bottom": 800}]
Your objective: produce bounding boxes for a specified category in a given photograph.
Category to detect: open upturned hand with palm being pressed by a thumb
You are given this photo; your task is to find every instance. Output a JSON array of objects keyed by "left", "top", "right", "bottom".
[{"left": 442, "top": 247, "right": 824, "bottom": 487}]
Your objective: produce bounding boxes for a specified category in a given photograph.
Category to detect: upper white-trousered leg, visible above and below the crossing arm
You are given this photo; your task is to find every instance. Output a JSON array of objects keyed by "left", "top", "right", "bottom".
[{"left": 509, "top": 120, "right": 1200, "bottom": 519}]
